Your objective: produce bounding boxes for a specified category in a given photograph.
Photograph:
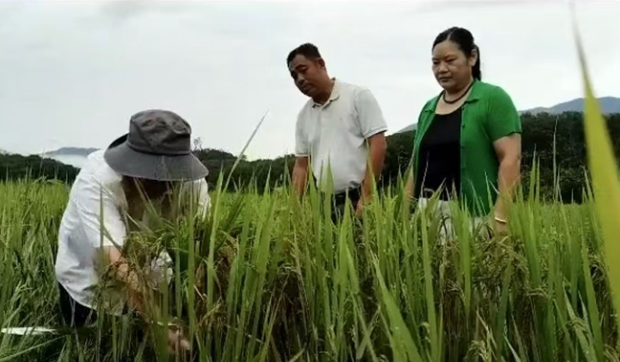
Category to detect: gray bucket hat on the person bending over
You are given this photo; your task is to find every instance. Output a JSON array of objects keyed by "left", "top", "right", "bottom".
[{"left": 104, "top": 110, "right": 209, "bottom": 181}]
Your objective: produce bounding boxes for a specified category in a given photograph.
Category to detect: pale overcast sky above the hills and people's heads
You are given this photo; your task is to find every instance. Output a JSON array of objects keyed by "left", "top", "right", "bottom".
[{"left": 0, "top": 0, "right": 620, "bottom": 158}]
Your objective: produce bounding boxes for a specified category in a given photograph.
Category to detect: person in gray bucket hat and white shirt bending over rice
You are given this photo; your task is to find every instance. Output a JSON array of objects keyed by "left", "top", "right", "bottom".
[{"left": 55, "top": 110, "right": 210, "bottom": 350}]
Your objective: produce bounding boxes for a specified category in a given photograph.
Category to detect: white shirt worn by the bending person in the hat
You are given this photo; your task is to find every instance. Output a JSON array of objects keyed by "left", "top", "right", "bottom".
[{"left": 55, "top": 150, "right": 210, "bottom": 314}]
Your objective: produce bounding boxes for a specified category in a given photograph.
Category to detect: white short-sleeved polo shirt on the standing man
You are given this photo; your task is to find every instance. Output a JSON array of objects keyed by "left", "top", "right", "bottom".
[{"left": 295, "top": 79, "right": 387, "bottom": 193}]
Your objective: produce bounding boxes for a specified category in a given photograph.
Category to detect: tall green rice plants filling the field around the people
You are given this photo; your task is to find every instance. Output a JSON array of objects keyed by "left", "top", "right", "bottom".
[{"left": 0, "top": 171, "right": 620, "bottom": 362}]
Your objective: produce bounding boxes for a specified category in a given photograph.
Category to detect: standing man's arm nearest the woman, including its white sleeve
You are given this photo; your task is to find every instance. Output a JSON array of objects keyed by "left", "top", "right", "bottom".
[{"left": 355, "top": 89, "right": 387, "bottom": 202}]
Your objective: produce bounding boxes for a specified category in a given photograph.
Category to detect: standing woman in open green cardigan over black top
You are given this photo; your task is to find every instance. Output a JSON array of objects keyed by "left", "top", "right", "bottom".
[{"left": 406, "top": 27, "right": 521, "bottom": 233}]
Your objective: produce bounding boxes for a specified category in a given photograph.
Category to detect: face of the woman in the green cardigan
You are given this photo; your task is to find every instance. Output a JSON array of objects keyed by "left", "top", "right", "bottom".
[{"left": 433, "top": 40, "right": 477, "bottom": 91}]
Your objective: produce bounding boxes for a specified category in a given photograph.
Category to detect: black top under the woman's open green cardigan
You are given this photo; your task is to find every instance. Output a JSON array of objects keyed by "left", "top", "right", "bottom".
[{"left": 414, "top": 108, "right": 461, "bottom": 200}]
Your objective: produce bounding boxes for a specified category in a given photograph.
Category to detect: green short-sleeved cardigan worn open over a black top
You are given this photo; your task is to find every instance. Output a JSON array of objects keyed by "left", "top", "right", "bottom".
[{"left": 413, "top": 80, "right": 521, "bottom": 216}]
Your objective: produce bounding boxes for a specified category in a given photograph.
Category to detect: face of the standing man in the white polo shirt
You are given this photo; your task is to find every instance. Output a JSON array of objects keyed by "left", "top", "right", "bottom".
[{"left": 289, "top": 54, "right": 327, "bottom": 97}]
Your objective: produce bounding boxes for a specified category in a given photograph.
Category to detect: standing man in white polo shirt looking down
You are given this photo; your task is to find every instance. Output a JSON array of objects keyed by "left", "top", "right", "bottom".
[{"left": 286, "top": 43, "right": 387, "bottom": 220}]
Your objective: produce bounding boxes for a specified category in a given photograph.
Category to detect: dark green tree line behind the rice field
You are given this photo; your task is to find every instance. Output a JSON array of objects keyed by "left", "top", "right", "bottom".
[{"left": 0, "top": 112, "right": 620, "bottom": 202}]
